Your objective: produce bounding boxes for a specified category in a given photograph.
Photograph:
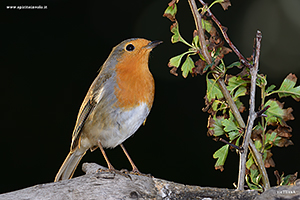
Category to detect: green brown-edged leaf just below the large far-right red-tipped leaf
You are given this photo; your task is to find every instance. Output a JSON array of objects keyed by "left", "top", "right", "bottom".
[{"left": 264, "top": 99, "right": 284, "bottom": 123}]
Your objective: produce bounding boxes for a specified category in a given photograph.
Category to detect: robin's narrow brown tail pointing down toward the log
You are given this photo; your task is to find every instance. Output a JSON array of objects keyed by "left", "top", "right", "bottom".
[{"left": 54, "top": 147, "right": 86, "bottom": 182}]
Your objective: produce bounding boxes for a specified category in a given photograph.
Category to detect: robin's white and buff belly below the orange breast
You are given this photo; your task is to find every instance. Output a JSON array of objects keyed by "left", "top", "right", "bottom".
[{"left": 81, "top": 103, "right": 150, "bottom": 148}]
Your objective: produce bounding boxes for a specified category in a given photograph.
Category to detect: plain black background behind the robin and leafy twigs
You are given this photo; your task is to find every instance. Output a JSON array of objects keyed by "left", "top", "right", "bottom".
[{"left": 0, "top": 0, "right": 300, "bottom": 193}]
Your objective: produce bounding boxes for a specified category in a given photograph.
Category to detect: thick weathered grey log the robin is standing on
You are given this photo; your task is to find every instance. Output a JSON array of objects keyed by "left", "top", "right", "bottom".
[{"left": 0, "top": 163, "right": 258, "bottom": 200}]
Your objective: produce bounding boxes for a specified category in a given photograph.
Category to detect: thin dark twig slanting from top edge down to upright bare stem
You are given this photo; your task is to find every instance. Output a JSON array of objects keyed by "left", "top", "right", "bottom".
[{"left": 199, "top": 0, "right": 252, "bottom": 68}]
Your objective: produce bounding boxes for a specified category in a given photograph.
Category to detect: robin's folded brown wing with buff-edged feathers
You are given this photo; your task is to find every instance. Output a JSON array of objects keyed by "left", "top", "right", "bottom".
[{"left": 71, "top": 74, "right": 110, "bottom": 151}]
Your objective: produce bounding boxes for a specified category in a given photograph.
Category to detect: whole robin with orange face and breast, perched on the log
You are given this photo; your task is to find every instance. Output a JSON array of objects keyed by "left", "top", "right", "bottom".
[{"left": 54, "top": 38, "right": 162, "bottom": 182}]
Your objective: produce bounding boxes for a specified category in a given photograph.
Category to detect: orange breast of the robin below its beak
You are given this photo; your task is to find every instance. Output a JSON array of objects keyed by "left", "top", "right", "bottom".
[{"left": 115, "top": 52, "right": 154, "bottom": 110}]
